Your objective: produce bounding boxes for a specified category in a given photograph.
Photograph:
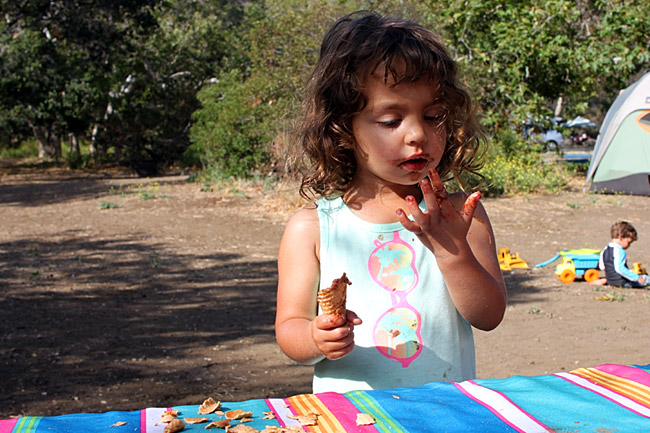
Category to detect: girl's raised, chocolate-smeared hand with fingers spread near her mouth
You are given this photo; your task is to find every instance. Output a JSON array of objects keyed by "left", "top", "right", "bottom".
[{"left": 397, "top": 169, "right": 481, "bottom": 259}]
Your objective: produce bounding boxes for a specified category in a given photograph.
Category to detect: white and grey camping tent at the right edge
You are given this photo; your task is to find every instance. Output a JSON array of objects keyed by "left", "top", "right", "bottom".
[{"left": 587, "top": 72, "right": 650, "bottom": 195}]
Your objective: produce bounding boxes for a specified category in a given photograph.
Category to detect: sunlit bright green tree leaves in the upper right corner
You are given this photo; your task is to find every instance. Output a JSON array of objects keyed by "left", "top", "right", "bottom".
[{"left": 427, "top": 0, "right": 650, "bottom": 127}]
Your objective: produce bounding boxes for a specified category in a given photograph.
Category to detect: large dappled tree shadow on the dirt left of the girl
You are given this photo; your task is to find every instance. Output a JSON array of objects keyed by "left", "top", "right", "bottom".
[{"left": 0, "top": 233, "right": 308, "bottom": 418}]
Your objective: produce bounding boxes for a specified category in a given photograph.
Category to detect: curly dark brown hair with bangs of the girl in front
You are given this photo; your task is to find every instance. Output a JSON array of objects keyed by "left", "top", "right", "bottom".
[{"left": 298, "top": 11, "right": 484, "bottom": 198}]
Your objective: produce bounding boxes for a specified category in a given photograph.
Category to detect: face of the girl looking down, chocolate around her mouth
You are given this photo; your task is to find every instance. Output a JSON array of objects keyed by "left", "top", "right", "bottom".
[{"left": 352, "top": 71, "right": 446, "bottom": 193}]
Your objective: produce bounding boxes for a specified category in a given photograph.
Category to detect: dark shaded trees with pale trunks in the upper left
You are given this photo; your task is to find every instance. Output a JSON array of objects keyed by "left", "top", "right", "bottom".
[{"left": 0, "top": 0, "right": 244, "bottom": 165}]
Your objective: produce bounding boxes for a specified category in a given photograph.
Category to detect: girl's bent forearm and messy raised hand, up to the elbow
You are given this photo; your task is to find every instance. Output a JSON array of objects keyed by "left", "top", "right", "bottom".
[{"left": 398, "top": 171, "right": 507, "bottom": 331}]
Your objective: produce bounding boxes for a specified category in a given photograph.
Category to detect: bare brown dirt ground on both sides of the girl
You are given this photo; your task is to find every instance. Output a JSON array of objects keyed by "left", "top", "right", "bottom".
[{"left": 0, "top": 163, "right": 650, "bottom": 419}]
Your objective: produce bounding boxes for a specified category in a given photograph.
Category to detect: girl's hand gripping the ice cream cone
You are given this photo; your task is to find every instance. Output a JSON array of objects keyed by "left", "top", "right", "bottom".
[{"left": 311, "top": 310, "right": 361, "bottom": 359}]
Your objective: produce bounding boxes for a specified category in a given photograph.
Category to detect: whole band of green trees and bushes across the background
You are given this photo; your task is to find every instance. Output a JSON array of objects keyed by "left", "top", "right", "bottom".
[{"left": 0, "top": 0, "right": 650, "bottom": 194}]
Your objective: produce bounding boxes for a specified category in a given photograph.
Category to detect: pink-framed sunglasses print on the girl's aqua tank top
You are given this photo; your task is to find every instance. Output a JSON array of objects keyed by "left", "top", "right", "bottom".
[{"left": 368, "top": 231, "right": 422, "bottom": 368}]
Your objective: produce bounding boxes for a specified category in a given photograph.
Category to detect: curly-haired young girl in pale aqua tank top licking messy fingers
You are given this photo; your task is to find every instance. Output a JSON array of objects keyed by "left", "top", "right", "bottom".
[{"left": 275, "top": 12, "right": 506, "bottom": 392}]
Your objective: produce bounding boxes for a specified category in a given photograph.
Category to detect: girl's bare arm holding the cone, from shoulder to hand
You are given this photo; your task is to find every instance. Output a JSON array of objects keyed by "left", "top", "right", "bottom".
[{"left": 275, "top": 209, "right": 360, "bottom": 364}]
